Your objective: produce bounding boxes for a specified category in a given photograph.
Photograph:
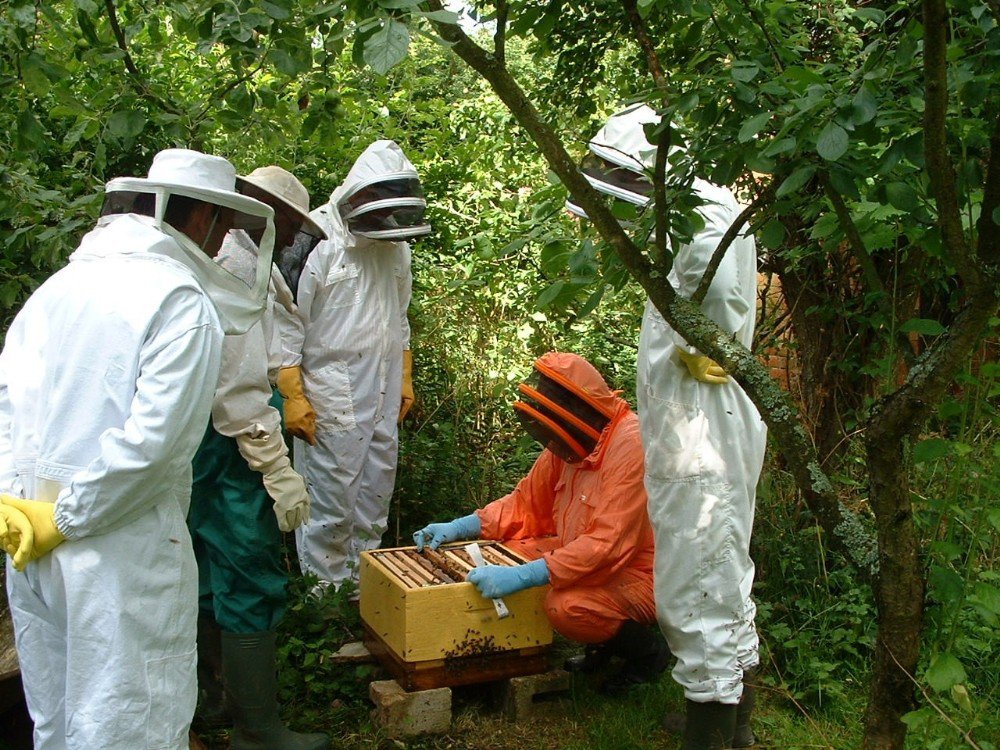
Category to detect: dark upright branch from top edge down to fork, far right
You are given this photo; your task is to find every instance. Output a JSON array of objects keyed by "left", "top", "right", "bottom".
[{"left": 923, "top": 0, "right": 982, "bottom": 287}]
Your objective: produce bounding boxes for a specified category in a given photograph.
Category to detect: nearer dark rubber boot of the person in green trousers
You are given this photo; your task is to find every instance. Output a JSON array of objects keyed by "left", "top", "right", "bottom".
[{"left": 222, "top": 631, "right": 330, "bottom": 750}]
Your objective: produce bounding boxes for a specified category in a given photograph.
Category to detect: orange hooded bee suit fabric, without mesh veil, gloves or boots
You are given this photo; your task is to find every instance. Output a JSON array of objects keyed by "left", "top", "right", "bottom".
[{"left": 476, "top": 353, "right": 656, "bottom": 643}]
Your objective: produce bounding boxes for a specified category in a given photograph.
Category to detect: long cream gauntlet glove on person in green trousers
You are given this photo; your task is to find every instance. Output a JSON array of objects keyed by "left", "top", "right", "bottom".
[{"left": 236, "top": 431, "right": 309, "bottom": 531}]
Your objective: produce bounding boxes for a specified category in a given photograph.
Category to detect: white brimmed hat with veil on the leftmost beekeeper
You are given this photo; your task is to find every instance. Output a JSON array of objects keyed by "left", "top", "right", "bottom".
[{"left": 101, "top": 149, "right": 274, "bottom": 334}]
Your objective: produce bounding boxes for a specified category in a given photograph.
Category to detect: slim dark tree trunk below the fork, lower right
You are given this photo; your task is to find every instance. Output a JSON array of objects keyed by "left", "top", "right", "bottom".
[{"left": 864, "top": 438, "right": 924, "bottom": 750}]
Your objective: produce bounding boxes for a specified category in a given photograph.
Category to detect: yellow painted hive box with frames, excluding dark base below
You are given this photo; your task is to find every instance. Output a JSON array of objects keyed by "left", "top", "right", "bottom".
[{"left": 361, "top": 542, "right": 552, "bottom": 663}]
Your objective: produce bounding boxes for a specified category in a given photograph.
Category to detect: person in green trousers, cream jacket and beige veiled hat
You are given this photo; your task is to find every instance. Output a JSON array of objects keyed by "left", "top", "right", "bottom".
[{"left": 188, "top": 166, "right": 329, "bottom": 750}]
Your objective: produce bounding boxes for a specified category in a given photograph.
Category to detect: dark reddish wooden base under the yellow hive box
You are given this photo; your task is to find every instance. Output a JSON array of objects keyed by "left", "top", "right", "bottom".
[{"left": 364, "top": 623, "right": 549, "bottom": 690}]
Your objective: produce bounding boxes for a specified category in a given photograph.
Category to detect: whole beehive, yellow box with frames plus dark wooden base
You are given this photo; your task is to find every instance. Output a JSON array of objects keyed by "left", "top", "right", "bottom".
[{"left": 361, "top": 542, "right": 552, "bottom": 690}]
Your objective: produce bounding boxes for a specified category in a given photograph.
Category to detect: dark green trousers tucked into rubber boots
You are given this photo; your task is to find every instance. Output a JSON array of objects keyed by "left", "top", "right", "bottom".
[{"left": 188, "top": 396, "right": 288, "bottom": 633}]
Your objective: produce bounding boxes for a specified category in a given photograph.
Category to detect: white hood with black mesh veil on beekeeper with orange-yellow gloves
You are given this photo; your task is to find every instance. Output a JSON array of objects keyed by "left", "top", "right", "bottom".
[{"left": 330, "top": 140, "right": 431, "bottom": 241}]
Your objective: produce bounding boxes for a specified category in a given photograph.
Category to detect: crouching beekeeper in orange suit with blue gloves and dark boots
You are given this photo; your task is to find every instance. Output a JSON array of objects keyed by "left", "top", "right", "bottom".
[{"left": 413, "top": 352, "right": 669, "bottom": 693}]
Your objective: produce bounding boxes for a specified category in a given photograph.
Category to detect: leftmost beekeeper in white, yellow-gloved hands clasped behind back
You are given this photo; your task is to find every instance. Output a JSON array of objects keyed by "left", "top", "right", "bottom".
[{"left": 0, "top": 149, "right": 274, "bottom": 750}]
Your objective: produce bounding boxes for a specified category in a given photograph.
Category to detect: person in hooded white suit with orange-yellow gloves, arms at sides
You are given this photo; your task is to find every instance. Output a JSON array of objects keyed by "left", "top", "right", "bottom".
[{"left": 278, "top": 141, "right": 430, "bottom": 587}]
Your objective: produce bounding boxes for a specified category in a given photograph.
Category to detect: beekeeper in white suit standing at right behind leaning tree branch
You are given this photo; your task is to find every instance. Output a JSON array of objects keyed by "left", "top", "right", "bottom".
[{"left": 568, "top": 106, "right": 767, "bottom": 750}]
